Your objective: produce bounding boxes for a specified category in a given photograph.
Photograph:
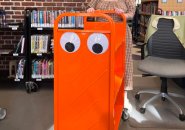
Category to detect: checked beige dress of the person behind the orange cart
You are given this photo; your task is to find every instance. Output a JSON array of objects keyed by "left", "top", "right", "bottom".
[{"left": 88, "top": 0, "right": 135, "bottom": 90}]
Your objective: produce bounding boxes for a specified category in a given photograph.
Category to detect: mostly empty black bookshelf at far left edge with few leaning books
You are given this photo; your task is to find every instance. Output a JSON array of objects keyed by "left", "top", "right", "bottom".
[{"left": 0, "top": 23, "right": 26, "bottom": 82}]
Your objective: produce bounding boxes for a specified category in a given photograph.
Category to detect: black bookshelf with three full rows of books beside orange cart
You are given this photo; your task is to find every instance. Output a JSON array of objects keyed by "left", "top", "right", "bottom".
[{"left": 29, "top": 10, "right": 84, "bottom": 85}]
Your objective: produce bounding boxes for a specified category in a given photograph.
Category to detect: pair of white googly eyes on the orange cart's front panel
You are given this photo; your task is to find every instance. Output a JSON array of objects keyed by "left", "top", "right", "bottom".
[{"left": 60, "top": 32, "right": 109, "bottom": 54}]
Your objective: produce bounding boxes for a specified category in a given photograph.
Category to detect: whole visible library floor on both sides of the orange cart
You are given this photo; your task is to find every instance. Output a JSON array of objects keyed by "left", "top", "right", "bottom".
[{"left": 0, "top": 44, "right": 185, "bottom": 130}]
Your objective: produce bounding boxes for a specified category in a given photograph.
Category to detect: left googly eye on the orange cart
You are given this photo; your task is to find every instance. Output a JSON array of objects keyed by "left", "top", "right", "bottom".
[{"left": 60, "top": 32, "right": 80, "bottom": 53}]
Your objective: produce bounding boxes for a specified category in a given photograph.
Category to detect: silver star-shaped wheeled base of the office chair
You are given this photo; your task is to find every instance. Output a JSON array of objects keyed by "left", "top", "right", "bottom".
[{"left": 135, "top": 90, "right": 185, "bottom": 121}]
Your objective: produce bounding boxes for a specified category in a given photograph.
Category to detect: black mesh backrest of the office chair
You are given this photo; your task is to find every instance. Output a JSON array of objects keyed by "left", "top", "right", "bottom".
[{"left": 147, "top": 18, "right": 185, "bottom": 59}]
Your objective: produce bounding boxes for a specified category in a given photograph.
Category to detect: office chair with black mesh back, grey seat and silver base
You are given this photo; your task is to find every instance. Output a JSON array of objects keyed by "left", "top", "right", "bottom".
[{"left": 135, "top": 18, "right": 185, "bottom": 121}]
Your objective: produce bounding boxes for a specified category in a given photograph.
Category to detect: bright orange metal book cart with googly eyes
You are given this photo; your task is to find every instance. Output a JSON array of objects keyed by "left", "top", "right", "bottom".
[{"left": 54, "top": 11, "right": 126, "bottom": 130}]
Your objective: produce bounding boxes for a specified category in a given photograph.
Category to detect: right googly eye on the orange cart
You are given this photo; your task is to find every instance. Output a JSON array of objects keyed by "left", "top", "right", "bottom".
[{"left": 87, "top": 33, "right": 109, "bottom": 54}]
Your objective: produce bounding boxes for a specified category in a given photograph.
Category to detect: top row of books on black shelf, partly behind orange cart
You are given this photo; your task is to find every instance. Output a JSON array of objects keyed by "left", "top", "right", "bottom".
[{"left": 30, "top": 10, "right": 83, "bottom": 30}]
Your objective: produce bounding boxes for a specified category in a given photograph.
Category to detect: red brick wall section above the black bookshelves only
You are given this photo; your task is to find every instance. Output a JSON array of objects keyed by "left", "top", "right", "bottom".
[{"left": 0, "top": 0, "right": 90, "bottom": 22}]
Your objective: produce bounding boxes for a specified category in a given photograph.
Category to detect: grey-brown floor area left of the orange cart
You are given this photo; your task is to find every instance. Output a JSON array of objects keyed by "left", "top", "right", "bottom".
[{"left": 0, "top": 84, "right": 53, "bottom": 130}]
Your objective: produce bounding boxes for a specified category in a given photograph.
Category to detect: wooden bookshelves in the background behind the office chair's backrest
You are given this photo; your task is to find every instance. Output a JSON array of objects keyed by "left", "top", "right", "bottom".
[{"left": 136, "top": 0, "right": 185, "bottom": 42}]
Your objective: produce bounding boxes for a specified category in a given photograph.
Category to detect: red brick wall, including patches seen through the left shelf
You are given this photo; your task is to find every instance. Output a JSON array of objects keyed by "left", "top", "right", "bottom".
[{"left": 0, "top": 0, "right": 90, "bottom": 70}]
